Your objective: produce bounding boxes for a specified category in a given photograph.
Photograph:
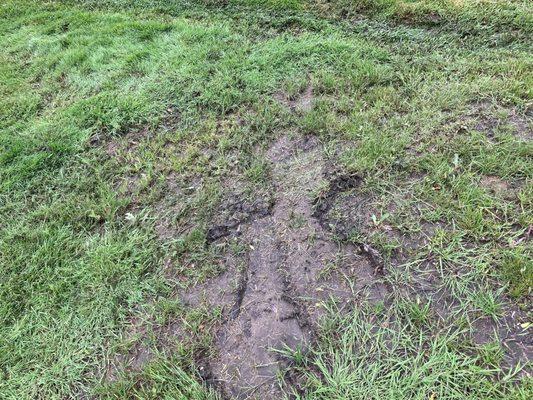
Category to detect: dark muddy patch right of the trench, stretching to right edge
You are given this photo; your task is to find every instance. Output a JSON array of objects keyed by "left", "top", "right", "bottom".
[{"left": 314, "top": 173, "right": 533, "bottom": 374}]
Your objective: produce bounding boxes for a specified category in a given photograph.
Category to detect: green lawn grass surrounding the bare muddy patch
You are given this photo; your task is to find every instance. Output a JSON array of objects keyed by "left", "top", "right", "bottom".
[{"left": 0, "top": 1, "right": 533, "bottom": 399}]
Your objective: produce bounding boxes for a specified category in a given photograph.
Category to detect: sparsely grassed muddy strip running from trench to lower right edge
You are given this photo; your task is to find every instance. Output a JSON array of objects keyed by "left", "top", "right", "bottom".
[{"left": 319, "top": 178, "right": 533, "bottom": 376}]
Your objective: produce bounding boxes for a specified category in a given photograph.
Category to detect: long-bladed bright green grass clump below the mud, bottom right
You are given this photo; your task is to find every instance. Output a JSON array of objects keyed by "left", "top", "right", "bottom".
[{"left": 288, "top": 304, "right": 528, "bottom": 400}]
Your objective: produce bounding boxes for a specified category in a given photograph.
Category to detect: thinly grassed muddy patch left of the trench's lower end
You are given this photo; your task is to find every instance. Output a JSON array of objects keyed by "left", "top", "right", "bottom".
[{"left": 104, "top": 250, "right": 242, "bottom": 383}]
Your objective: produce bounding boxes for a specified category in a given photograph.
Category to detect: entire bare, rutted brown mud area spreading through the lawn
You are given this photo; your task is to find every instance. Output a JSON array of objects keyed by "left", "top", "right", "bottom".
[{"left": 102, "top": 86, "right": 533, "bottom": 399}]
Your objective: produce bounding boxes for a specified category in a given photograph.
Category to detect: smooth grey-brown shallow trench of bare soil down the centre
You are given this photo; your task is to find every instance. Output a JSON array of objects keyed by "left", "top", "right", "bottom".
[{"left": 202, "top": 136, "right": 387, "bottom": 399}]
